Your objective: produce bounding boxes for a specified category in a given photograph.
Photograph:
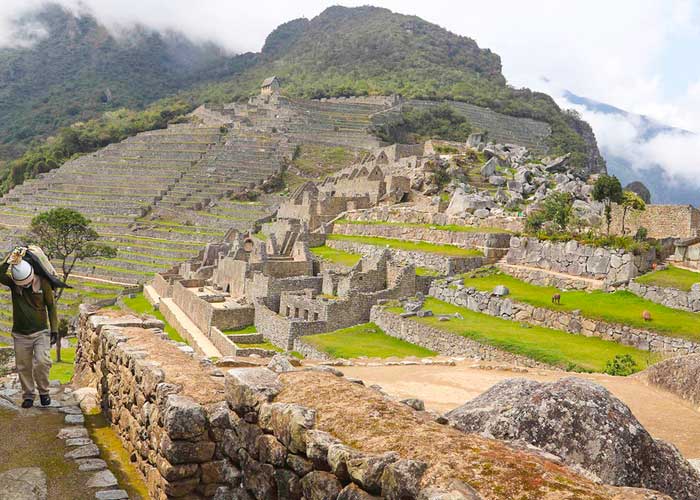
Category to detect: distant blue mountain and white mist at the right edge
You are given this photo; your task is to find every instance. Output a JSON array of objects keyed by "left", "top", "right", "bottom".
[{"left": 563, "top": 91, "right": 700, "bottom": 206}]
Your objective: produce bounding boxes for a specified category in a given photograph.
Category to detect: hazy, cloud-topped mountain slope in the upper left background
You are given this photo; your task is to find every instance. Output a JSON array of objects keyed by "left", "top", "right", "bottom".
[{"left": 0, "top": 4, "right": 252, "bottom": 159}]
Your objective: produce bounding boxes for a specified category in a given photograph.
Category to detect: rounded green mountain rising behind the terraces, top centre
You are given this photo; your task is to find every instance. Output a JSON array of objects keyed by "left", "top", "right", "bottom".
[{"left": 197, "top": 6, "right": 605, "bottom": 172}]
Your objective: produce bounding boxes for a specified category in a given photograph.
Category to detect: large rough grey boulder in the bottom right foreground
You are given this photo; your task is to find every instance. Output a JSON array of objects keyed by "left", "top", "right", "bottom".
[{"left": 446, "top": 377, "right": 700, "bottom": 500}]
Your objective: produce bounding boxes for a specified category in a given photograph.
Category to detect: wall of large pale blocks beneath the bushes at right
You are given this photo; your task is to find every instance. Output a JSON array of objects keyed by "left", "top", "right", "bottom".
[{"left": 506, "top": 236, "right": 656, "bottom": 285}]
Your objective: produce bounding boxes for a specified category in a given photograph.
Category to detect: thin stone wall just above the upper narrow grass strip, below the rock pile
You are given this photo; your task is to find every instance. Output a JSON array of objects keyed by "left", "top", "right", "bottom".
[{"left": 345, "top": 206, "right": 525, "bottom": 237}]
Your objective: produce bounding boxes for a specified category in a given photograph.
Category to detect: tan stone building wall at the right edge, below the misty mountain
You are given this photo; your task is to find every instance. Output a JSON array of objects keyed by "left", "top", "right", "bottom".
[{"left": 610, "top": 205, "right": 700, "bottom": 239}]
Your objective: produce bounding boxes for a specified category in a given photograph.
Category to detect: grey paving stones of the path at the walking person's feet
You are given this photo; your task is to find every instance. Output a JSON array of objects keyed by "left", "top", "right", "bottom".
[{"left": 0, "top": 375, "right": 129, "bottom": 500}]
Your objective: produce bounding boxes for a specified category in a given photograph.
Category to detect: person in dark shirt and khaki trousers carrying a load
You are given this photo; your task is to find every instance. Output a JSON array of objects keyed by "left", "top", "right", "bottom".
[{"left": 0, "top": 247, "right": 58, "bottom": 408}]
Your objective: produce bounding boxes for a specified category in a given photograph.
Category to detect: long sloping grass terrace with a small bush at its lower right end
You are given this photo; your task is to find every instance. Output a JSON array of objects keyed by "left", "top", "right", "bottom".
[{"left": 389, "top": 297, "right": 661, "bottom": 372}]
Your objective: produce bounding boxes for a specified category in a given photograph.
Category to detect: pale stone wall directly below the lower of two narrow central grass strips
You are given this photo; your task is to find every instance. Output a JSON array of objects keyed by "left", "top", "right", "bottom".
[{"left": 326, "top": 240, "right": 484, "bottom": 275}]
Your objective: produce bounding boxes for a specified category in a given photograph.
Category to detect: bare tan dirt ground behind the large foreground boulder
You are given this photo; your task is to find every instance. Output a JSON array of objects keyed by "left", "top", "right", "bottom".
[{"left": 342, "top": 362, "right": 700, "bottom": 458}]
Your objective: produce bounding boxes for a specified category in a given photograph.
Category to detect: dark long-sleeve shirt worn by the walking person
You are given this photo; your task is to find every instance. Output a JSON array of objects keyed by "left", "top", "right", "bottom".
[{"left": 0, "top": 262, "right": 58, "bottom": 335}]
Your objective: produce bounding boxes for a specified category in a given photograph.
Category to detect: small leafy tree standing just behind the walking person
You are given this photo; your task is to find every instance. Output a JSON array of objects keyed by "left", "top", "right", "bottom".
[{"left": 28, "top": 208, "right": 117, "bottom": 361}]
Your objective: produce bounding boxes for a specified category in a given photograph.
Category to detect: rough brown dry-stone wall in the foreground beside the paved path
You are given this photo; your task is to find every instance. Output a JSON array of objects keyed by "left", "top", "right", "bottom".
[{"left": 76, "top": 309, "right": 470, "bottom": 500}]
